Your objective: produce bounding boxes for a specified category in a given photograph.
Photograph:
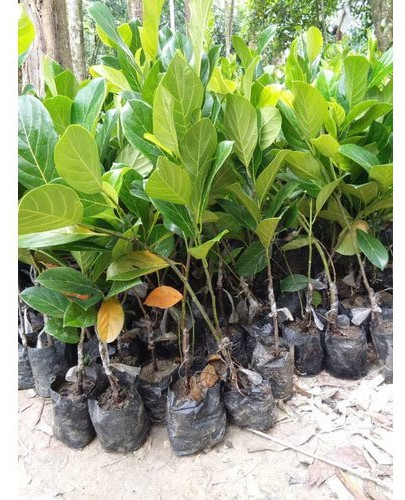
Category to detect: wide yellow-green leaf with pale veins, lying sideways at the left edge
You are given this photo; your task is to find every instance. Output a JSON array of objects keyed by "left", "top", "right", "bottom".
[{"left": 18, "top": 184, "right": 83, "bottom": 234}]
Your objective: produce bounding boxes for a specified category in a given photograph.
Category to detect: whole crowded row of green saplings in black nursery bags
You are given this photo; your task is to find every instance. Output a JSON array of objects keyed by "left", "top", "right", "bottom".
[{"left": 18, "top": 0, "right": 393, "bottom": 455}]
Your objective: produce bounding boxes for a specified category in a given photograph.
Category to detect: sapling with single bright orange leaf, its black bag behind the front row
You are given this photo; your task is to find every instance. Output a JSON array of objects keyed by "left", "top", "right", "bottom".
[{"left": 137, "top": 285, "right": 183, "bottom": 424}]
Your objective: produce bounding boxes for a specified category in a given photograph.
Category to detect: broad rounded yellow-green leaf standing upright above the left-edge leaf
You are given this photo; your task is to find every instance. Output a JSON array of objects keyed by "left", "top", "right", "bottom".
[{"left": 55, "top": 125, "right": 102, "bottom": 194}]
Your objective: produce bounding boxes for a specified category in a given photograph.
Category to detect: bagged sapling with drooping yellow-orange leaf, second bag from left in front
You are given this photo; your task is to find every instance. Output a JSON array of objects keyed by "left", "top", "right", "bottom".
[{"left": 88, "top": 297, "right": 150, "bottom": 452}]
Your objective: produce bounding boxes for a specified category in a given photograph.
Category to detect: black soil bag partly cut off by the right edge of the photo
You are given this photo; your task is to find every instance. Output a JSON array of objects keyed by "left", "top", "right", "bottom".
[{"left": 370, "top": 308, "right": 394, "bottom": 384}]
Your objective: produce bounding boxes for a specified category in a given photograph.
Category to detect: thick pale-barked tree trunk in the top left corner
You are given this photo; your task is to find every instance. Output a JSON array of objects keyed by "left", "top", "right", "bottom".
[{"left": 21, "top": 0, "right": 72, "bottom": 96}]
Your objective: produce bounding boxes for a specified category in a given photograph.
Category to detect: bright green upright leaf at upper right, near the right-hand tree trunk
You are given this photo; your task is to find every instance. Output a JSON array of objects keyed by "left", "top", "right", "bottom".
[{"left": 343, "top": 56, "right": 369, "bottom": 108}]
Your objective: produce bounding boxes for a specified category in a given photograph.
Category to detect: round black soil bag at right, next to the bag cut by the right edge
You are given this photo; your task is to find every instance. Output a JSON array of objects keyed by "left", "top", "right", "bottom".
[{"left": 325, "top": 325, "right": 368, "bottom": 380}]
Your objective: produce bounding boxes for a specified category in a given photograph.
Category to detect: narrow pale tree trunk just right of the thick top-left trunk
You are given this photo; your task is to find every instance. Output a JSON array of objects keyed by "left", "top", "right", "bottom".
[{"left": 66, "top": 0, "right": 86, "bottom": 82}]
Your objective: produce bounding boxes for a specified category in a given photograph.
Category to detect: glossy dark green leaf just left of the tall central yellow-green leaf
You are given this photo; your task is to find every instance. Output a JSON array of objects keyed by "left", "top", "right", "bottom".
[{"left": 121, "top": 99, "right": 163, "bottom": 163}]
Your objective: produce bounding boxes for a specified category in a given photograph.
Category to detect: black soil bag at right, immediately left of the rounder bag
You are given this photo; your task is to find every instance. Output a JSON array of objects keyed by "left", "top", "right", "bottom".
[{"left": 281, "top": 320, "right": 323, "bottom": 375}]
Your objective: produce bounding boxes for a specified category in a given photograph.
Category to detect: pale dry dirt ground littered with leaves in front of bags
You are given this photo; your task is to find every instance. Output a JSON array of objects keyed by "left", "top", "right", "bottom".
[{"left": 18, "top": 367, "right": 393, "bottom": 500}]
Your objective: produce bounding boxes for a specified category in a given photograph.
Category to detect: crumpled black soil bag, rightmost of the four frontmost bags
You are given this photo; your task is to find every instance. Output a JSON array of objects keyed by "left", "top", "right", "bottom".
[{"left": 224, "top": 376, "right": 277, "bottom": 431}]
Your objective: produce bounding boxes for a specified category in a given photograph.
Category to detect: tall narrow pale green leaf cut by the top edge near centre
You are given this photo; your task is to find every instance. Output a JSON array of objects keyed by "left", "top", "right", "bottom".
[{"left": 188, "top": 0, "right": 212, "bottom": 76}]
